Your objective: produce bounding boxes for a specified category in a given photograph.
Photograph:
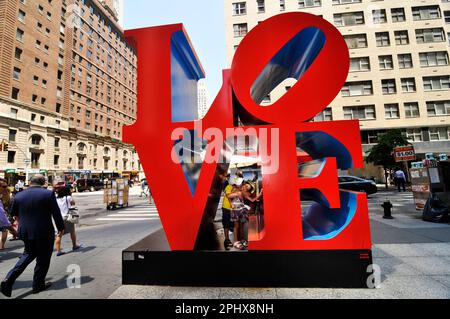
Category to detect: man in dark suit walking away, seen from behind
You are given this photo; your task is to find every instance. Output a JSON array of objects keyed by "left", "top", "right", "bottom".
[{"left": 1, "top": 175, "right": 64, "bottom": 297}]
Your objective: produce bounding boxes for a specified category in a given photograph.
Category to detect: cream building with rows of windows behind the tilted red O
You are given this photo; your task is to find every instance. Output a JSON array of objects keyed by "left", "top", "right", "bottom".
[{"left": 225, "top": 0, "right": 450, "bottom": 178}]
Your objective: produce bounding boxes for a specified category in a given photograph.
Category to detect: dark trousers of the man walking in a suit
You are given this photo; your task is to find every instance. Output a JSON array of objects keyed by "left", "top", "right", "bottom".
[{"left": 5, "top": 238, "right": 55, "bottom": 290}]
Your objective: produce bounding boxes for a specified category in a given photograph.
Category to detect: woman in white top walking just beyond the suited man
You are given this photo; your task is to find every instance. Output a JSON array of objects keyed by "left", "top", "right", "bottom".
[{"left": 55, "top": 185, "right": 81, "bottom": 257}]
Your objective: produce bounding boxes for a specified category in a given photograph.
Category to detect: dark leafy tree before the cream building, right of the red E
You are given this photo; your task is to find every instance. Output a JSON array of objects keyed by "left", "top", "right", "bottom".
[{"left": 366, "top": 130, "right": 409, "bottom": 188}]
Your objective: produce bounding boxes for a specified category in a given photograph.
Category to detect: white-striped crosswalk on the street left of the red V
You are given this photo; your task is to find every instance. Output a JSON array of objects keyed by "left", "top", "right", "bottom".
[{"left": 97, "top": 203, "right": 159, "bottom": 222}]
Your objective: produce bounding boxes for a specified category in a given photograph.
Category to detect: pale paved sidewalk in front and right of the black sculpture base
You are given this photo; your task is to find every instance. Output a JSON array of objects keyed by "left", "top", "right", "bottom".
[{"left": 110, "top": 188, "right": 450, "bottom": 299}]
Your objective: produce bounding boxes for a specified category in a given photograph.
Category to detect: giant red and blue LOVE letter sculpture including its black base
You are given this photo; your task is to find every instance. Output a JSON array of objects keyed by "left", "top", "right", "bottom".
[{"left": 123, "top": 13, "right": 372, "bottom": 287}]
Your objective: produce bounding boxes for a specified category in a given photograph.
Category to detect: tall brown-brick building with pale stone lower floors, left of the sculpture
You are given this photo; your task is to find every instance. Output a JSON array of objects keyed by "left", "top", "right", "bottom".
[{"left": 0, "top": 0, "right": 140, "bottom": 185}]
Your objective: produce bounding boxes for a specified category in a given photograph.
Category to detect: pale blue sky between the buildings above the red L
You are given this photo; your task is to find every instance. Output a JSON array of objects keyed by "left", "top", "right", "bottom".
[{"left": 124, "top": 0, "right": 226, "bottom": 98}]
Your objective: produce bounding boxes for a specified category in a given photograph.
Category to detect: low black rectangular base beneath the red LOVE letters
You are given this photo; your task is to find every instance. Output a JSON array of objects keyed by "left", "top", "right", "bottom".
[{"left": 122, "top": 230, "right": 372, "bottom": 288}]
